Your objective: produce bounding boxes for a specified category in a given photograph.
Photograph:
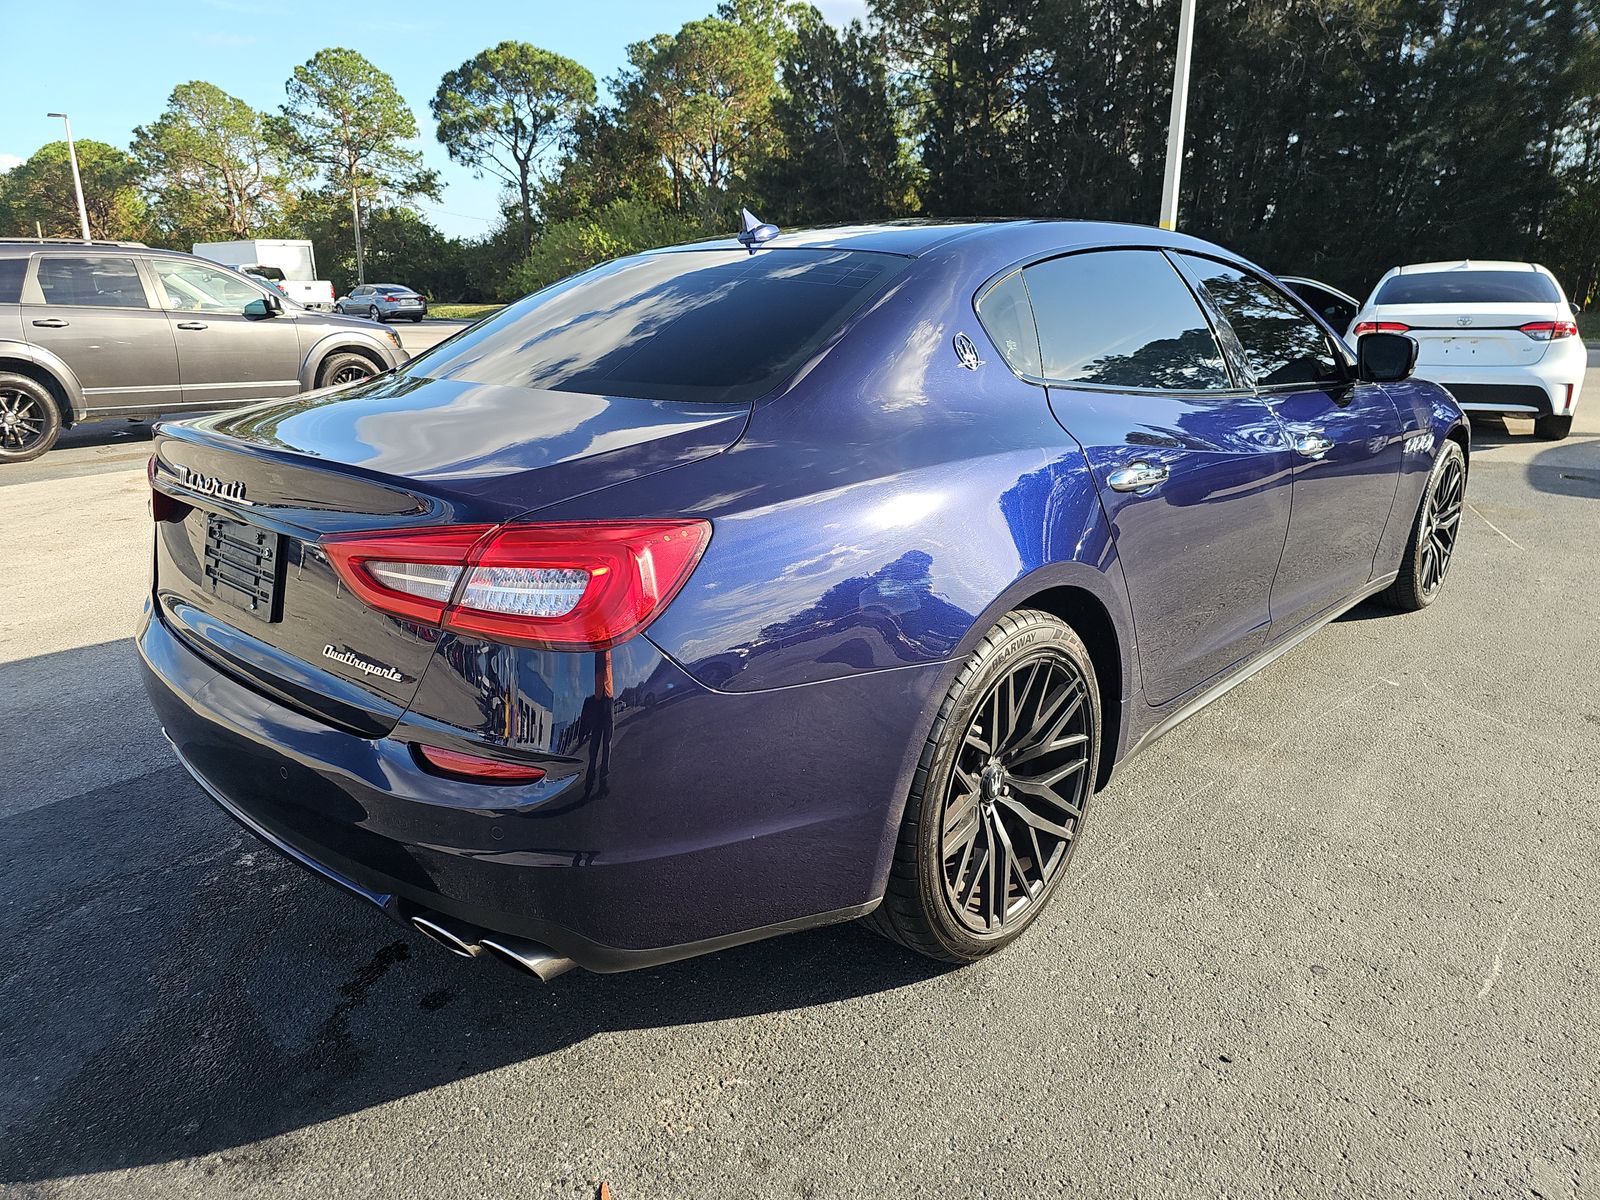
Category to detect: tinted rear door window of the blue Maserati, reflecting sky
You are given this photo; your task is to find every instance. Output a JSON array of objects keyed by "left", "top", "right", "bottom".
[{"left": 1022, "top": 250, "right": 1232, "bottom": 392}]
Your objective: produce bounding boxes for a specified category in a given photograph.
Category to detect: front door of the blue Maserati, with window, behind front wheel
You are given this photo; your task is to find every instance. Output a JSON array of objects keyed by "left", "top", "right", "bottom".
[{"left": 1174, "top": 254, "right": 1405, "bottom": 637}]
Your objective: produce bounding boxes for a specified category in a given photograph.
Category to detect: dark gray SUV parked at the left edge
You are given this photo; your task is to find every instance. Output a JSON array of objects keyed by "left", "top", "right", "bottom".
[{"left": 0, "top": 240, "right": 410, "bottom": 462}]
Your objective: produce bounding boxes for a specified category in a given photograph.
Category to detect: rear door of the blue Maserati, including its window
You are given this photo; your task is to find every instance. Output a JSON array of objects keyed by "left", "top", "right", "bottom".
[{"left": 1022, "top": 250, "right": 1290, "bottom": 706}]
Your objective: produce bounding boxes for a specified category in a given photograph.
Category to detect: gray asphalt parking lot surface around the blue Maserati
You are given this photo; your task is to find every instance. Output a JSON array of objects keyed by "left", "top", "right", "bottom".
[{"left": 0, "top": 364, "right": 1600, "bottom": 1200}]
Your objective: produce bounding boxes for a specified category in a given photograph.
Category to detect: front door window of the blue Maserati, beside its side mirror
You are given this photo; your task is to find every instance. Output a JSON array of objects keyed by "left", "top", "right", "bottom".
[{"left": 1181, "top": 254, "right": 1344, "bottom": 387}]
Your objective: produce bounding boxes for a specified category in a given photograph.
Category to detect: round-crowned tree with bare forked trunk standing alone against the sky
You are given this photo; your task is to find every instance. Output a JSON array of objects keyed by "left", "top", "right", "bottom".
[{"left": 432, "top": 42, "right": 595, "bottom": 251}]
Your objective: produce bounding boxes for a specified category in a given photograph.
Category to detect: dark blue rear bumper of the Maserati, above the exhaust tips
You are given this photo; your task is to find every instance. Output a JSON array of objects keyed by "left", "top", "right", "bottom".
[{"left": 138, "top": 614, "right": 944, "bottom": 971}]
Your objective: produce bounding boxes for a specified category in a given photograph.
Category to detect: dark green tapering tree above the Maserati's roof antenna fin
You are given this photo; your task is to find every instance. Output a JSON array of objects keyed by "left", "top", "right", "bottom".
[{"left": 752, "top": 8, "right": 915, "bottom": 224}]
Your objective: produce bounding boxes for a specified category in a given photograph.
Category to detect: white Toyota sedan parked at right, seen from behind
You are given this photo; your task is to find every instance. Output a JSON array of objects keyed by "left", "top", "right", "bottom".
[{"left": 1352, "top": 259, "right": 1589, "bottom": 442}]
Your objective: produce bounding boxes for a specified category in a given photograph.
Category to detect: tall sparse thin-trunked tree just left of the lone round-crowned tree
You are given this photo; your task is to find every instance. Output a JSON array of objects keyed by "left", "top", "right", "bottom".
[{"left": 278, "top": 46, "right": 438, "bottom": 275}]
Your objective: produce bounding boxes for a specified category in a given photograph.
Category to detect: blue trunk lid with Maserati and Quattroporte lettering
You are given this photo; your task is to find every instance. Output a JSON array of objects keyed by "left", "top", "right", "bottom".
[{"left": 152, "top": 378, "right": 749, "bottom": 736}]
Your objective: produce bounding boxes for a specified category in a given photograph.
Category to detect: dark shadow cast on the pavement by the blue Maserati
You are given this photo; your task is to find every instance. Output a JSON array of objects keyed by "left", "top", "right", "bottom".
[{"left": 0, "top": 668, "right": 947, "bottom": 1184}]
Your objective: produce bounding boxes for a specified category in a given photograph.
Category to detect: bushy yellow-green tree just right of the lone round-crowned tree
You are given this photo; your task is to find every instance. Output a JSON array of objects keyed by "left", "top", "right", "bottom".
[{"left": 613, "top": 18, "right": 776, "bottom": 219}]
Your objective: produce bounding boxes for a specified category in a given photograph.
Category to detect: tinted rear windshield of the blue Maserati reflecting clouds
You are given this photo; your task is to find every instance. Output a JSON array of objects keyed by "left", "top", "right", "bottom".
[{"left": 400, "top": 250, "right": 907, "bottom": 403}]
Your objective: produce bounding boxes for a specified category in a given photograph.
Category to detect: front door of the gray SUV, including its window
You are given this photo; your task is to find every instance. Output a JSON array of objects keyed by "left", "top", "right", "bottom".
[{"left": 149, "top": 258, "right": 301, "bottom": 408}]
